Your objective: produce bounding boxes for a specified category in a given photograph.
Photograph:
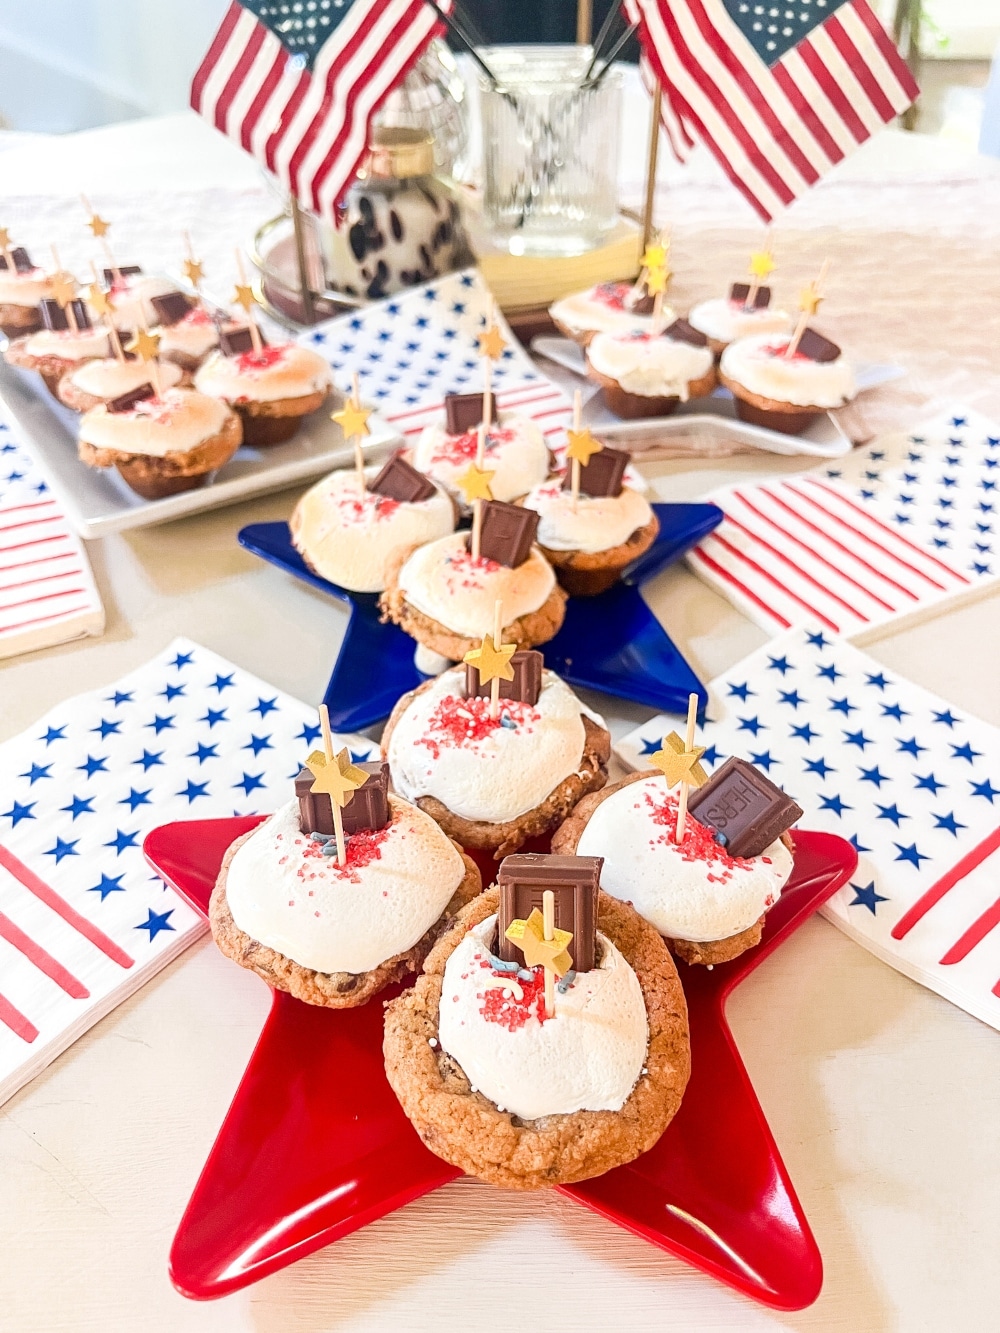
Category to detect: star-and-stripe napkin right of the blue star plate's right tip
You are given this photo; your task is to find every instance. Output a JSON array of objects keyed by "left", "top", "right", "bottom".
[{"left": 687, "top": 412, "right": 1000, "bottom": 639}]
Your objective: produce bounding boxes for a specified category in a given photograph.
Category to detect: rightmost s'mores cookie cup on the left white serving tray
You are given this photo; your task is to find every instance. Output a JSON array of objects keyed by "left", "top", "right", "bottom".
[{"left": 195, "top": 329, "right": 333, "bottom": 448}]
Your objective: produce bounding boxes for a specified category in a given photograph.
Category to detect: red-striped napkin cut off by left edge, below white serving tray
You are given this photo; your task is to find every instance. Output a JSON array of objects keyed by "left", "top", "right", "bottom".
[{"left": 0, "top": 407, "right": 104, "bottom": 657}]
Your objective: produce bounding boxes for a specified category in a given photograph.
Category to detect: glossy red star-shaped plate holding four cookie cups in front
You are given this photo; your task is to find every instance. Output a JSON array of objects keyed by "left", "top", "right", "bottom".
[{"left": 145, "top": 817, "right": 857, "bottom": 1310}]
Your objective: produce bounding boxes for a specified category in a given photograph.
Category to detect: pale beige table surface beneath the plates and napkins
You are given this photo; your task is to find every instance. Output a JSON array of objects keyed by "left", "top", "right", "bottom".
[{"left": 0, "top": 119, "right": 1000, "bottom": 1333}]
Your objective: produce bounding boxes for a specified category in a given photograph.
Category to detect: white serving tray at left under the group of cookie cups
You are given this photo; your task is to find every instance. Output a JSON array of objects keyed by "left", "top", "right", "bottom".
[{"left": 0, "top": 363, "right": 401, "bottom": 539}]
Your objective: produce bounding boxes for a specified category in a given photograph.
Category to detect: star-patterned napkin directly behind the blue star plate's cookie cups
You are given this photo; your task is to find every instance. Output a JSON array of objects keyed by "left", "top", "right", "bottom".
[{"left": 300, "top": 269, "right": 572, "bottom": 463}]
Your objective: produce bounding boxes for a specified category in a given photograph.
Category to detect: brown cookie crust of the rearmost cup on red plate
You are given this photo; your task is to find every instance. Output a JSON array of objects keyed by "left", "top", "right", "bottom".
[{"left": 381, "top": 680, "right": 611, "bottom": 861}]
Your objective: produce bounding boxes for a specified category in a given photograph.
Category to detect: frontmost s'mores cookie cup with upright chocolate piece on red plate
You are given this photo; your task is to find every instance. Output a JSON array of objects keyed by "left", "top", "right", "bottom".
[{"left": 383, "top": 856, "right": 691, "bottom": 1189}]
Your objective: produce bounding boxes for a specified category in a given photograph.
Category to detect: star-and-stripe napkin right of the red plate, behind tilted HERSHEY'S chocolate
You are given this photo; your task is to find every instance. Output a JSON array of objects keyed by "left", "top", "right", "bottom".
[{"left": 617, "top": 625, "right": 1000, "bottom": 1028}]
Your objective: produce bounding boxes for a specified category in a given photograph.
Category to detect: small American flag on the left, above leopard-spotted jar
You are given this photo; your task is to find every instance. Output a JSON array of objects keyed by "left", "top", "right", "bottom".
[{"left": 191, "top": 0, "right": 449, "bottom": 217}]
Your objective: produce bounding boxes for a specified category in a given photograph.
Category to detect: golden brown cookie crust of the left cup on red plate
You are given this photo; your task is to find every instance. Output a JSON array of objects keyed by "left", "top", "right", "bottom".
[{"left": 208, "top": 829, "right": 483, "bottom": 1009}]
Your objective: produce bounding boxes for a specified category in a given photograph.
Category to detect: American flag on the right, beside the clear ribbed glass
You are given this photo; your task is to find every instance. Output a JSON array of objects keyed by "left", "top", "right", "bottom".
[{"left": 625, "top": 0, "right": 919, "bottom": 220}]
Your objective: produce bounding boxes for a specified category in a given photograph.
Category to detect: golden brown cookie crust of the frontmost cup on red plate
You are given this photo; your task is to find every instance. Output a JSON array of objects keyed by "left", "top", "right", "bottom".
[{"left": 383, "top": 889, "right": 691, "bottom": 1189}]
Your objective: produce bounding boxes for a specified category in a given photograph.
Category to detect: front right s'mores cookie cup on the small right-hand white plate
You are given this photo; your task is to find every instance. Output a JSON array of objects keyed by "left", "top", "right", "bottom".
[{"left": 719, "top": 328, "right": 857, "bottom": 435}]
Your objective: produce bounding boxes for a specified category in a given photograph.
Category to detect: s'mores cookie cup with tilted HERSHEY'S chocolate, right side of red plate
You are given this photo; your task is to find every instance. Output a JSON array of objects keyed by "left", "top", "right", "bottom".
[{"left": 552, "top": 746, "right": 801, "bottom": 965}]
